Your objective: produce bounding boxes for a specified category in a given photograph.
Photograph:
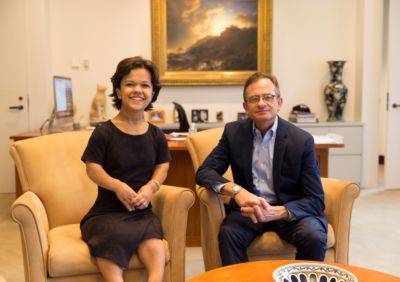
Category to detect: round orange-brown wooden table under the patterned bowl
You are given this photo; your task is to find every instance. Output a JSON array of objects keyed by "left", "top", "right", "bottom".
[{"left": 188, "top": 260, "right": 400, "bottom": 282}]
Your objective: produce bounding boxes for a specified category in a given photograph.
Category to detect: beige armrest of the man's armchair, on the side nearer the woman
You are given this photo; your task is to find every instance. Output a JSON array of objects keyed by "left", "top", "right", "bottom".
[{"left": 196, "top": 187, "right": 225, "bottom": 271}]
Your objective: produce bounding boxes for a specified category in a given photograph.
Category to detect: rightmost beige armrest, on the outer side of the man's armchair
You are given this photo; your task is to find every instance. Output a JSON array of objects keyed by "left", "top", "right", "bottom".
[{"left": 321, "top": 178, "right": 360, "bottom": 263}]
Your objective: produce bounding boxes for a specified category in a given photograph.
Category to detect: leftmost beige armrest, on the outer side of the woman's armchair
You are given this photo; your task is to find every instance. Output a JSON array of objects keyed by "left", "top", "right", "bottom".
[{"left": 11, "top": 192, "right": 49, "bottom": 281}]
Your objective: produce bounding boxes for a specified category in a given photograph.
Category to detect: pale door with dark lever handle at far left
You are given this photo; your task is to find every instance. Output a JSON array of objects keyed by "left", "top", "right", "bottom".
[{"left": 0, "top": 0, "right": 28, "bottom": 193}]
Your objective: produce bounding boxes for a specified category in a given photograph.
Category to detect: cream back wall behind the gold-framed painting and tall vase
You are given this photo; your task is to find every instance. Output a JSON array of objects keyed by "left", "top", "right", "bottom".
[{"left": 48, "top": 0, "right": 360, "bottom": 125}]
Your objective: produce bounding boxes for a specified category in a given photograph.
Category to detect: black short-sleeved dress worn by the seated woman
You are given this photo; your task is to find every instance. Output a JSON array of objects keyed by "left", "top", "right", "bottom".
[{"left": 81, "top": 121, "right": 171, "bottom": 268}]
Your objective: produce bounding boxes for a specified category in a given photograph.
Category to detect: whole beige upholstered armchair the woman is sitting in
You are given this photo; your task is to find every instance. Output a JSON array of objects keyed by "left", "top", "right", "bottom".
[{"left": 10, "top": 131, "right": 194, "bottom": 282}]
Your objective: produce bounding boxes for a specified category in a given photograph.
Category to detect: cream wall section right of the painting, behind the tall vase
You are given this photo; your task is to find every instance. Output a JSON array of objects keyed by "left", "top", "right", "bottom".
[{"left": 272, "top": 0, "right": 360, "bottom": 121}]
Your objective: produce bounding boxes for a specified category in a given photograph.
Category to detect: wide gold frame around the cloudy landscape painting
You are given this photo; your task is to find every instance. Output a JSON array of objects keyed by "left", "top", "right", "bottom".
[{"left": 151, "top": 0, "right": 272, "bottom": 86}]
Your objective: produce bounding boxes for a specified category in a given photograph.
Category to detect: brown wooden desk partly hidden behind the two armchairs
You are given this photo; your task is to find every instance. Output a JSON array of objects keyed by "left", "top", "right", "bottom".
[{"left": 10, "top": 130, "right": 344, "bottom": 246}]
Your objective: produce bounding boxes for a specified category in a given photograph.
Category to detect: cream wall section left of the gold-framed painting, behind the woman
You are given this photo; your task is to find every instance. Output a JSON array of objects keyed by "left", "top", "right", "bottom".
[{"left": 49, "top": 0, "right": 151, "bottom": 123}]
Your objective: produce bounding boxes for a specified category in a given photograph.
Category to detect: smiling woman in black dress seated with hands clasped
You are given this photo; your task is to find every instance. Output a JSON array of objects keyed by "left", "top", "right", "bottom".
[{"left": 81, "top": 57, "right": 170, "bottom": 282}]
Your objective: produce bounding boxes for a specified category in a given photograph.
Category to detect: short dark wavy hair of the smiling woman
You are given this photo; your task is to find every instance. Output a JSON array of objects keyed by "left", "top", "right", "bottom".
[{"left": 110, "top": 56, "right": 161, "bottom": 111}]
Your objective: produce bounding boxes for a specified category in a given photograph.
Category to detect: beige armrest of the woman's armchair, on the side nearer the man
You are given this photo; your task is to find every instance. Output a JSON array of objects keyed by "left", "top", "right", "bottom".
[{"left": 151, "top": 185, "right": 195, "bottom": 282}]
